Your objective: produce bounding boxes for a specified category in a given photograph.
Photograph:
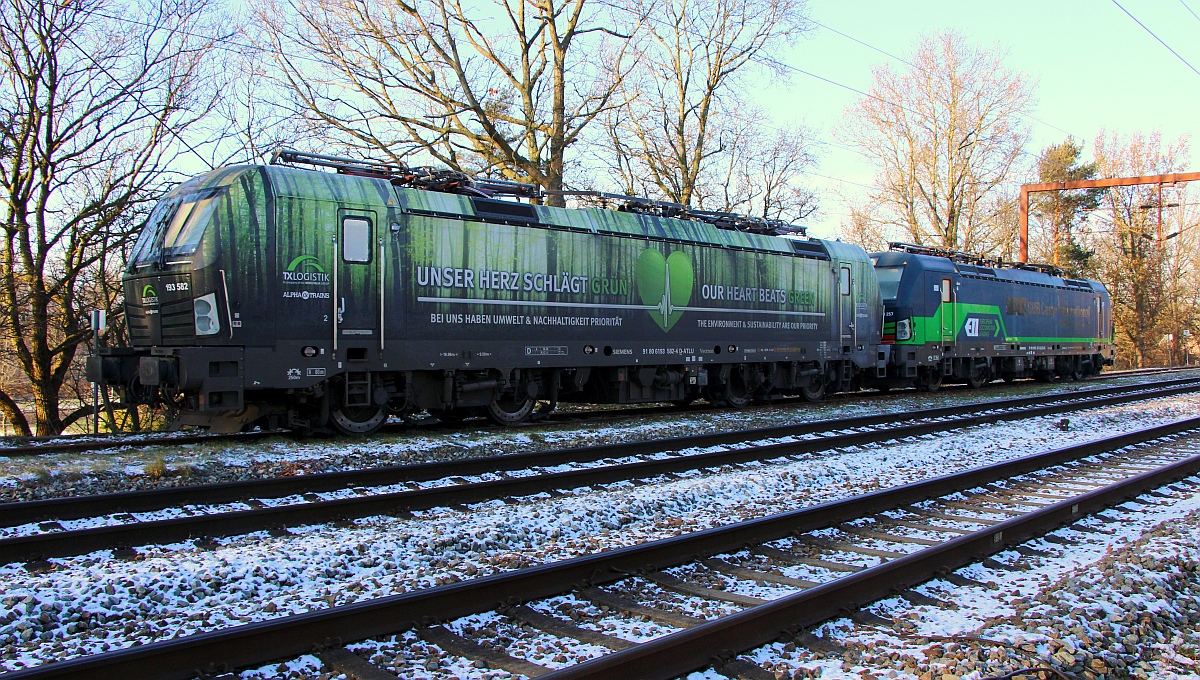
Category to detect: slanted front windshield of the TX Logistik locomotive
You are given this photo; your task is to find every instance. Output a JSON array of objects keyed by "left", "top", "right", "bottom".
[{"left": 130, "top": 188, "right": 223, "bottom": 269}]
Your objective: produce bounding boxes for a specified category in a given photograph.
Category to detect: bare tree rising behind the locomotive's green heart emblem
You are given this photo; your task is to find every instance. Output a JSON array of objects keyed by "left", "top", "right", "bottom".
[{"left": 605, "top": 0, "right": 808, "bottom": 206}]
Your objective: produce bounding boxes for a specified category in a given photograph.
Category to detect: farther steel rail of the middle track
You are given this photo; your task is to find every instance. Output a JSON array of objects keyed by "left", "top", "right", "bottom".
[{"left": 0, "top": 377, "right": 1200, "bottom": 526}]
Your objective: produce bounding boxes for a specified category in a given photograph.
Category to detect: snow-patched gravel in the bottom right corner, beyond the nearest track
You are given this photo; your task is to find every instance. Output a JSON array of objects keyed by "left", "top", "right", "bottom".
[{"left": 734, "top": 477, "right": 1200, "bottom": 680}]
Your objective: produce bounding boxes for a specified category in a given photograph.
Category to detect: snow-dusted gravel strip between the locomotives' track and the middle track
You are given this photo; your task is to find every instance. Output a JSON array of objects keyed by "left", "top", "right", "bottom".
[{"left": 0, "top": 371, "right": 1200, "bottom": 501}]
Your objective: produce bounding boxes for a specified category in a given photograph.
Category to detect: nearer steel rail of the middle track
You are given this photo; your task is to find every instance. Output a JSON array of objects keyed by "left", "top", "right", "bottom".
[{"left": 0, "top": 385, "right": 1200, "bottom": 564}]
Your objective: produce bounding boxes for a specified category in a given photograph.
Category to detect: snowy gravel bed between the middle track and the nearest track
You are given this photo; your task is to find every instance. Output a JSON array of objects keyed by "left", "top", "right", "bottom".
[{"left": 0, "top": 396, "right": 1200, "bottom": 670}]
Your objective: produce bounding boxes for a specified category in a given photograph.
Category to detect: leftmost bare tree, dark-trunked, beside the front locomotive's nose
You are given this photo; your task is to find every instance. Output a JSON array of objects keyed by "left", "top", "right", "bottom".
[{"left": 0, "top": 0, "right": 223, "bottom": 434}]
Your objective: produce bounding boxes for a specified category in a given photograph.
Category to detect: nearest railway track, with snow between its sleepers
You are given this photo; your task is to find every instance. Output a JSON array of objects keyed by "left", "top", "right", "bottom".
[{"left": 6, "top": 419, "right": 1200, "bottom": 680}]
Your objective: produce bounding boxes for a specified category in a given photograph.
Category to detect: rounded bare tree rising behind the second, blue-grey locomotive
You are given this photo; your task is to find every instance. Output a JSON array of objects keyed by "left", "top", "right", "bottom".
[{"left": 840, "top": 32, "right": 1033, "bottom": 252}]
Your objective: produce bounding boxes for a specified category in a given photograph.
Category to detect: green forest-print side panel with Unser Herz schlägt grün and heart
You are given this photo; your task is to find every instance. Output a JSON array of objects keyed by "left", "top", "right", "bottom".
[{"left": 406, "top": 215, "right": 830, "bottom": 339}]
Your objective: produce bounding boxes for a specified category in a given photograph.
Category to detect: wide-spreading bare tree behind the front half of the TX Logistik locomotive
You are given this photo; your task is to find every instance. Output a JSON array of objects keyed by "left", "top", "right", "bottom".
[{"left": 258, "top": 0, "right": 632, "bottom": 205}]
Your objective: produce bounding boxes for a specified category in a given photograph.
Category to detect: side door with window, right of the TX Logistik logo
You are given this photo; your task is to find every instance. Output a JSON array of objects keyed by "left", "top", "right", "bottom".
[{"left": 332, "top": 209, "right": 382, "bottom": 361}]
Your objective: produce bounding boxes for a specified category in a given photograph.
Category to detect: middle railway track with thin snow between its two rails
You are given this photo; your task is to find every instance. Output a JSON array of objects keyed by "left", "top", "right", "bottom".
[{"left": 0, "top": 378, "right": 1200, "bottom": 568}]
